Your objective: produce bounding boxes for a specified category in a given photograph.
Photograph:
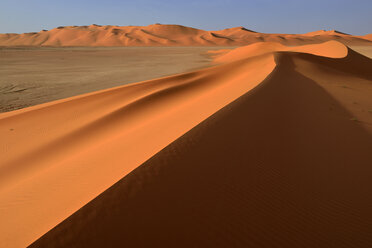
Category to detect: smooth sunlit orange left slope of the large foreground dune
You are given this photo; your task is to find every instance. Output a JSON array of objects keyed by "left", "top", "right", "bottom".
[{"left": 0, "top": 45, "right": 275, "bottom": 247}]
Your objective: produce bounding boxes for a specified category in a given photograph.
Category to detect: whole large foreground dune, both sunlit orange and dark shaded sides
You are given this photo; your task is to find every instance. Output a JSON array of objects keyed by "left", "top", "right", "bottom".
[{"left": 0, "top": 42, "right": 372, "bottom": 247}]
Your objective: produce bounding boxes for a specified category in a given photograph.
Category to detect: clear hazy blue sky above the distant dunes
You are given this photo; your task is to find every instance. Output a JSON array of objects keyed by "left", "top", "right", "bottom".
[{"left": 0, "top": 0, "right": 372, "bottom": 35}]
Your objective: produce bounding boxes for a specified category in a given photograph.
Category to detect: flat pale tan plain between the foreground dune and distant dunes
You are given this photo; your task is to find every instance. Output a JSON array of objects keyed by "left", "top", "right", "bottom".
[{"left": 0, "top": 47, "right": 231, "bottom": 112}]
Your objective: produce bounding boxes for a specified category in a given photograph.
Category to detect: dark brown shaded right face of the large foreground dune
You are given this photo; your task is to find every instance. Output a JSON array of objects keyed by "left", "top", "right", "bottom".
[{"left": 25, "top": 41, "right": 372, "bottom": 247}]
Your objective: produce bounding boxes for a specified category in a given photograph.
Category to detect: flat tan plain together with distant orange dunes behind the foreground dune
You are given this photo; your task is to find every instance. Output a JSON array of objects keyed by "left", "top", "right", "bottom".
[{"left": 0, "top": 24, "right": 372, "bottom": 112}]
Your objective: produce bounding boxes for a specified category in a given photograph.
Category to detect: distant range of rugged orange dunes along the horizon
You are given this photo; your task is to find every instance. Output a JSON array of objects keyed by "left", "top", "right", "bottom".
[{"left": 0, "top": 24, "right": 372, "bottom": 47}]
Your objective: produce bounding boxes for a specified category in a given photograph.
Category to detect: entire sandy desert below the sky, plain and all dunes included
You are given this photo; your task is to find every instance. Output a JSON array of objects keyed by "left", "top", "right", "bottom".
[{"left": 0, "top": 20, "right": 372, "bottom": 248}]
